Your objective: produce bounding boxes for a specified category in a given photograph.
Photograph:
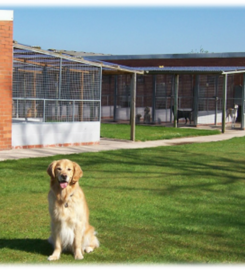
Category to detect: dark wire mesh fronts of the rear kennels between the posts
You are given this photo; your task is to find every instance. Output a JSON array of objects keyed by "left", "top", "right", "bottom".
[{"left": 102, "top": 74, "right": 238, "bottom": 124}]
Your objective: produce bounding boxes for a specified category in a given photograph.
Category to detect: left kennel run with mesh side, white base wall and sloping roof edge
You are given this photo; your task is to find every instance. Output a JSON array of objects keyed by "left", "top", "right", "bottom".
[{"left": 12, "top": 43, "right": 143, "bottom": 148}]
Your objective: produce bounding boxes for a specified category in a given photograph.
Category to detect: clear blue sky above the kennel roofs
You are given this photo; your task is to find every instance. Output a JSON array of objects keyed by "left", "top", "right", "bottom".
[{"left": 0, "top": 1, "right": 245, "bottom": 54}]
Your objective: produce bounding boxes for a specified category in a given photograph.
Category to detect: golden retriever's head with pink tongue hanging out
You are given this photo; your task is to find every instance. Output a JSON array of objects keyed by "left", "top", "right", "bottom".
[{"left": 47, "top": 159, "right": 83, "bottom": 189}]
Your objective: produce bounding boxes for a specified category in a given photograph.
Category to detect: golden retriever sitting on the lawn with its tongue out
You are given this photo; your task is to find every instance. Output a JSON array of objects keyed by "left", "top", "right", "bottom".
[{"left": 47, "top": 159, "right": 99, "bottom": 261}]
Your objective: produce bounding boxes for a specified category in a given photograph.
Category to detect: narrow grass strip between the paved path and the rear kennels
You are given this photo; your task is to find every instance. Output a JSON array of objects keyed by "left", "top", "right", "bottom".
[{"left": 101, "top": 124, "right": 220, "bottom": 141}]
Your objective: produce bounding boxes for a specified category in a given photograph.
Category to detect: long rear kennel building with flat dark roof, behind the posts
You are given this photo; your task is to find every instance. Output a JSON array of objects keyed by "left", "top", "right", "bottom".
[{"left": 88, "top": 53, "right": 245, "bottom": 128}]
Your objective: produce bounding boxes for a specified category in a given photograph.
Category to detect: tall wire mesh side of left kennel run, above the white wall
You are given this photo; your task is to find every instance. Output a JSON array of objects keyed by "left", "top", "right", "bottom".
[{"left": 12, "top": 49, "right": 101, "bottom": 122}]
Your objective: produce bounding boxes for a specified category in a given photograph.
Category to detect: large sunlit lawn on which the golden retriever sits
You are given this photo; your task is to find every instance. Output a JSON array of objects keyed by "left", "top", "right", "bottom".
[{"left": 0, "top": 138, "right": 245, "bottom": 269}]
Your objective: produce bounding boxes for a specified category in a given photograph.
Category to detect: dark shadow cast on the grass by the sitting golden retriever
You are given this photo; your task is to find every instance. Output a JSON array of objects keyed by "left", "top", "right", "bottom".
[{"left": 0, "top": 238, "right": 53, "bottom": 256}]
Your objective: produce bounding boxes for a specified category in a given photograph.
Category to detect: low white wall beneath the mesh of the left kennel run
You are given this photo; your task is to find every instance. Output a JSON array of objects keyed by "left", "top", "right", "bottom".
[{"left": 12, "top": 122, "right": 100, "bottom": 147}]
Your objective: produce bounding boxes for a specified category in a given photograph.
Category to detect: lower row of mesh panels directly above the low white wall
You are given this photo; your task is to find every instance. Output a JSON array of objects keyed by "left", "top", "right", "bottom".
[{"left": 12, "top": 98, "right": 101, "bottom": 122}]
